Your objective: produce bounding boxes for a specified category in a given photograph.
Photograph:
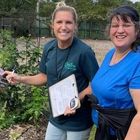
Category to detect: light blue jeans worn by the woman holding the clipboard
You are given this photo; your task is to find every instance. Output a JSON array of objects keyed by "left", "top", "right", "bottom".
[{"left": 45, "top": 122, "right": 91, "bottom": 140}]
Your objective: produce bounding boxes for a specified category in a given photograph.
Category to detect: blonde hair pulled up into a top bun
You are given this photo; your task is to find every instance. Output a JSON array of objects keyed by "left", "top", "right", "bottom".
[{"left": 51, "top": 1, "right": 78, "bottom": 24}]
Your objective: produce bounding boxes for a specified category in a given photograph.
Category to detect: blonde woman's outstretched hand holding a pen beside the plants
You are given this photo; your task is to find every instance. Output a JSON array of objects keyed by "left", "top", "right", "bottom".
[{"left": 3, "top": 71, "right": 21, "bottom": 85}]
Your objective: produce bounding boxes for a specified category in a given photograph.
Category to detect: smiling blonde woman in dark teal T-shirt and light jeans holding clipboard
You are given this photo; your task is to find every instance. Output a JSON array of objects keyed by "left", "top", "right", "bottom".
[{"left": 5, "top": 2, "right": 98, "bottom": 140}]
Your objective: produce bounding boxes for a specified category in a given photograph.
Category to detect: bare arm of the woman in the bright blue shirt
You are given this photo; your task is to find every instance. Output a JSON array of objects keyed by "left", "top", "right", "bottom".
[{"left": 125, "top": 89, "right": 140, "bottom": 140}]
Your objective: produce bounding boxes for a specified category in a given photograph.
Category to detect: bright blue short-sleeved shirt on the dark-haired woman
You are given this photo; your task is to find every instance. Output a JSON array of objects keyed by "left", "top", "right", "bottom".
[{"left": 91, "top": 49, "right": 140, "bottom": 125}]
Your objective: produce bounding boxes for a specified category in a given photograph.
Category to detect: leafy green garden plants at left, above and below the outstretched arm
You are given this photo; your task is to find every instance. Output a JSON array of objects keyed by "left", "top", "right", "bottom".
[{"left": 0, "top": 30, "right": 48, "bottom": 129}]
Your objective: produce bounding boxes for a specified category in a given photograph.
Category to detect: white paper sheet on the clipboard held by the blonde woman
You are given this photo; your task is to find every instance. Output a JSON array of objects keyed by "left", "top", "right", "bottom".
[{"left": 49, "top": 74, "right": 80, "bottom": 117}]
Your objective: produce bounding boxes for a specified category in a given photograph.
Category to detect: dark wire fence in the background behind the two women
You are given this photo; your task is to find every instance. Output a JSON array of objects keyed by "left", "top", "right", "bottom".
[{"left": 0, "top": 16, "right": 107, "bottom": 40}]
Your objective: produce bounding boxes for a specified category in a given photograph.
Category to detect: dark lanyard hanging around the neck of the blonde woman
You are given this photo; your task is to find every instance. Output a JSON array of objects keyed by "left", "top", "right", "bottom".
[{"left": 55, "top": 46, "right": 72, "bottom": 81}]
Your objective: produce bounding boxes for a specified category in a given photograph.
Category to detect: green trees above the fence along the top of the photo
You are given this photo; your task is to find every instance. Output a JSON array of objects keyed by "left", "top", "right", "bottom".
[{"left": 0, "top": 0, "right": 140, "bottom": 20}]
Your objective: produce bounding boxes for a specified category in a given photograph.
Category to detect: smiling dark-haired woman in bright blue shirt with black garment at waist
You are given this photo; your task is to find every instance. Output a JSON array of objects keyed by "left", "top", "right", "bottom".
[{"left": 92, "top": 6, "right": 140, "bottom": 140}]
